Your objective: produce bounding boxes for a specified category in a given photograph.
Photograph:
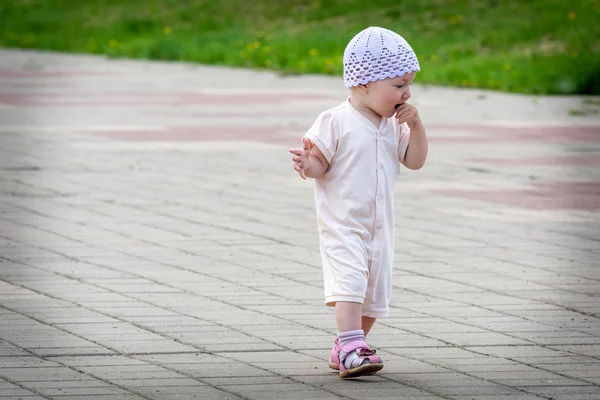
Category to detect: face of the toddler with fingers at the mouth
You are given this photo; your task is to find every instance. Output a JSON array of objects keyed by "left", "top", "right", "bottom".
[{"left": 367, "top": 71, "right": 417, "bottom": 118}]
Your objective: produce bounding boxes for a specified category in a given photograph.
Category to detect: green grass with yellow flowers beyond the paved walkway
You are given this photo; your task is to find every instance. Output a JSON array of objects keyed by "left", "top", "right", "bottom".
[{"left": 0, "top": 0, "right": 600, "bottom": 94}]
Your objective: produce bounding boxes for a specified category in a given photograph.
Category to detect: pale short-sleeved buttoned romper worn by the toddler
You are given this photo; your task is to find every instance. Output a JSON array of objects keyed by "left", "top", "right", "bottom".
[{"left": 305, "top": 100, "right": 410, "bottom": 318}]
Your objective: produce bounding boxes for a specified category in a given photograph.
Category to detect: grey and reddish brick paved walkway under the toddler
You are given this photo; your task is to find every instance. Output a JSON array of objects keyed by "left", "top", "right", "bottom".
[{"left": 0, "top": 51, "right": 600, "bottom": 400}]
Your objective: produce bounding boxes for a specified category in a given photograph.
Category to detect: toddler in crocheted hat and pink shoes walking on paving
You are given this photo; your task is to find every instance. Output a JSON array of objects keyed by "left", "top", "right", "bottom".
[{"left": 289, "top": 27, "right": 427, "bottom": 378}]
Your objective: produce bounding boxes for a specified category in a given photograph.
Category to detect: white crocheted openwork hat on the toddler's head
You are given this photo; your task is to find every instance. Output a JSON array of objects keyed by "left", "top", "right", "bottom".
[{"left": 344, "top": 26, "right": 421, "bottom": 87}]
